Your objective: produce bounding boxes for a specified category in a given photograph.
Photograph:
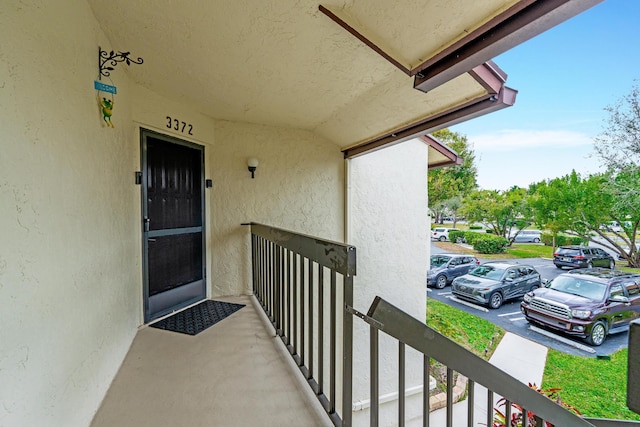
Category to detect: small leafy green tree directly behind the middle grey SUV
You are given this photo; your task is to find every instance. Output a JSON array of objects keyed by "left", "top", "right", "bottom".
[{"left": 460, "top": 187, "right": 533, "bottom": 244}]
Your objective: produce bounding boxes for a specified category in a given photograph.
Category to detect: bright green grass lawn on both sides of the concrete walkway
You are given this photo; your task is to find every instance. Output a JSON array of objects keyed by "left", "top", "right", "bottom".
[{"left": 427, "top": 299, "right": 640, "bottom": 421}]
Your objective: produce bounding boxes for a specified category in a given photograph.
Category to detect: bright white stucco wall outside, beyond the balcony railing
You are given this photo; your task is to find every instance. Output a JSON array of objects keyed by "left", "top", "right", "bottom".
[{"left": 348, "top": 140, "right": 429, "bottom": 425}]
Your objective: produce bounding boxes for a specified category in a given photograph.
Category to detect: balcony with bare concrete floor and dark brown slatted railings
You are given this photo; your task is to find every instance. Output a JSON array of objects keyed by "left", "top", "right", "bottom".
[{"left": 92, "top": 224, "right": 640, "bottom": 427}]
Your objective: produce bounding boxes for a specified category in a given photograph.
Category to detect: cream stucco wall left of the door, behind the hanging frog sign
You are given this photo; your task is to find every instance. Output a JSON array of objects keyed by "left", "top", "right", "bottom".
[{"left": 0, "top": 0, "right": 141, "bottom": 426}]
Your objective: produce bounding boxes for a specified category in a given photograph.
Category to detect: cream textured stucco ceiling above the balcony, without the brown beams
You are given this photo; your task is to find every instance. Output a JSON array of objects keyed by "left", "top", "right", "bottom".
[{"left": 88, "top": 0, "right": 592, "bottom": 154}]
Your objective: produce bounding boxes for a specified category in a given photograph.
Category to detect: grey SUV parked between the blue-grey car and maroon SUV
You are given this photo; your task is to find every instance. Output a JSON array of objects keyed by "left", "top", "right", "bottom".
[{"left": 451, "top": 262, "right": 542, "bottom": 308}]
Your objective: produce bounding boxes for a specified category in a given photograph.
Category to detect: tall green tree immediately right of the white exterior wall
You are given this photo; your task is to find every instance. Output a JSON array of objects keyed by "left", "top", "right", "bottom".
[{"left": 427, "top": 129, "right": 478, "bottom": 223}]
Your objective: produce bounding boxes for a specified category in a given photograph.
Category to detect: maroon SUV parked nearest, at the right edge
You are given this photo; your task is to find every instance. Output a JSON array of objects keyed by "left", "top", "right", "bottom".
[{"left": 520, "top": 268, "right": 640, "bottom": 346}]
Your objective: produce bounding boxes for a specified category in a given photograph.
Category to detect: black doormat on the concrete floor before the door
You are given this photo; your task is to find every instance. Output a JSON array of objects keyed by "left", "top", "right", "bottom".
[{"left": 149, "top": 300, "right": 245, "bottom": 335}]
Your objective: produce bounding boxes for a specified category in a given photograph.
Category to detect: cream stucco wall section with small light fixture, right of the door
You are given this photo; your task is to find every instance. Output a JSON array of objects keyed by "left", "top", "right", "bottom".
[{"left": 207, "top": 122, "right": 344, "bottom": 295}]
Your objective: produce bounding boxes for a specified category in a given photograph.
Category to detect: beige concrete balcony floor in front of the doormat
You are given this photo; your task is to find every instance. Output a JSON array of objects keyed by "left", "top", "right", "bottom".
[{"left": 92, "top": 296, "right": 332, "bottom": 427}]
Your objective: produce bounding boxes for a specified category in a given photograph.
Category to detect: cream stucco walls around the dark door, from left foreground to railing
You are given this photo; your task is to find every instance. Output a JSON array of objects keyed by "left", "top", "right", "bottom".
[{"left": 0, "top": 0, "right": 344, "bottom": 426}]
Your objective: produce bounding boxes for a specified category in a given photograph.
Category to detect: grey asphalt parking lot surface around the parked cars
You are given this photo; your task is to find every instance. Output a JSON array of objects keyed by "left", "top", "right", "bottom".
[{"left": 427, "top": 244, "right": 628, "bottom": 357}]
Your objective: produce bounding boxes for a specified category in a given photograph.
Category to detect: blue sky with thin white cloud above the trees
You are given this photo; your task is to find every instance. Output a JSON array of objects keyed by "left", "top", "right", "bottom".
[{"left": 449, "top": 0, "right": 640, "bottom": 190}]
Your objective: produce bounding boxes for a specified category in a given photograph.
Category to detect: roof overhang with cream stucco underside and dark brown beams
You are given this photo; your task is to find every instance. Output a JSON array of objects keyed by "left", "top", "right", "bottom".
[{"left": 87, "top": 0, "right": 601, "bottom": 157}]
